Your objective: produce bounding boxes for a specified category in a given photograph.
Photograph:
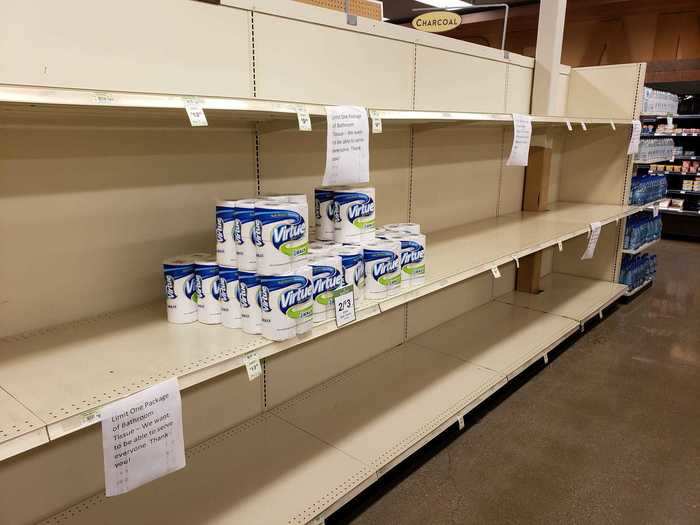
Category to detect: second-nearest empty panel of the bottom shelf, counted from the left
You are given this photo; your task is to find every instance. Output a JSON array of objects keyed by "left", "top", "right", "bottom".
[{"left": 273, "top": 343, "right": 506, "bottom": 472}]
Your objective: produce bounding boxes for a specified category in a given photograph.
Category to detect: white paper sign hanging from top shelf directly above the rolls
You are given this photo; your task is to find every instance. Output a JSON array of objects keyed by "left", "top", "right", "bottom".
[{"left": 323, "top": 106, "right": 369, "bottom": 186}]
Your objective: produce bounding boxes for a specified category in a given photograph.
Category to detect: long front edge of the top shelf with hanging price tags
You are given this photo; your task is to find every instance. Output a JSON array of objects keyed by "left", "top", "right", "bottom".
[{"left": 0, "top": 85, "right": 632, "bottom": 127}]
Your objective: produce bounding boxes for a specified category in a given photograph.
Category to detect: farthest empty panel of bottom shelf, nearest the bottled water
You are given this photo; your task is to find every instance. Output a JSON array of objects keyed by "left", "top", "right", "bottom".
[{"left": 496, "top": 273, "right": 627, "bottom": 324}]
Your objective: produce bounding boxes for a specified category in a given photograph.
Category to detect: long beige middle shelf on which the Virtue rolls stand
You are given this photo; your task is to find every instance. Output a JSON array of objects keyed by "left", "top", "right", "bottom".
[{"left": 0, "top": 199, "right": 639, "bottom": 453}]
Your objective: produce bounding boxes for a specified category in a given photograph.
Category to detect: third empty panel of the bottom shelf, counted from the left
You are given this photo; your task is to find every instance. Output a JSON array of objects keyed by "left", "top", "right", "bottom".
[{"left": 411, "top": 301, "right": 579, "bottom": 380}]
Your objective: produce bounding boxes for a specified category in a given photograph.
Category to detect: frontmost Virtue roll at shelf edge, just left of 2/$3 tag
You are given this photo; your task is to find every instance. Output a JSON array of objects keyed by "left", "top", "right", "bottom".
[{"left": 260, "top": 266, "right": 313, "bottom": 341}]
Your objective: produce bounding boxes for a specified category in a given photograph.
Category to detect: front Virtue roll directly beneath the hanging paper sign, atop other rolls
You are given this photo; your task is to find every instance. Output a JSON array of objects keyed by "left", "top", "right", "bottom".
[{"left": 333, "top": 188, "right": 375, "bottom": 242}]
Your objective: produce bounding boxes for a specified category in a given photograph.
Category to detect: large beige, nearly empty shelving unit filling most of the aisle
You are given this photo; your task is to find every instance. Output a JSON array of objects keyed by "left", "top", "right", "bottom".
[{"left": 0, "top": 0, "right": 644, "bottom": 524}]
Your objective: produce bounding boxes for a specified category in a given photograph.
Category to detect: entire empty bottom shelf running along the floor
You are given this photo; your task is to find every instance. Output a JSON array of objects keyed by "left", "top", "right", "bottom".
[{"left": 46, "top": 276, "right": 612, "bottom": 525}]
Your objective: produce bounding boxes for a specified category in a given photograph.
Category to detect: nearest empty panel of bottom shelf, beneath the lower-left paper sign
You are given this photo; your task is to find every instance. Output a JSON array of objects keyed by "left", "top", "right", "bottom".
[{"left": 45, "top": 414, "right": 372, "bottom": 525}]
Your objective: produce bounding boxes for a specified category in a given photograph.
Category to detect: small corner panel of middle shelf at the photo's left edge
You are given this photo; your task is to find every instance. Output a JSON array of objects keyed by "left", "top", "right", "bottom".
[{"left": 0, "top": 388, "right": 49, "bottom": 461}]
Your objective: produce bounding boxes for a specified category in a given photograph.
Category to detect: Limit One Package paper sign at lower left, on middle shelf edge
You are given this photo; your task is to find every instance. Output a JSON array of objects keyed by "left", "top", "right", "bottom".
[{"left": 101, "top": 378, "right": 185, "bottom": 496}]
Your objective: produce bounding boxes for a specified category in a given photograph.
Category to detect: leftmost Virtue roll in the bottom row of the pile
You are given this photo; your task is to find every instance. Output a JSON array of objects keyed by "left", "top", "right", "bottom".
[{"left": 163, "top": 255, "right": 197, "bottom": 324}]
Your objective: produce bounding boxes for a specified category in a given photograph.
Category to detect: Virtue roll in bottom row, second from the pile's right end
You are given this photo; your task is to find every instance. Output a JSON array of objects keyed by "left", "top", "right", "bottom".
[{"left": 363, "top": 240, "right": 401, "bottom": 300}]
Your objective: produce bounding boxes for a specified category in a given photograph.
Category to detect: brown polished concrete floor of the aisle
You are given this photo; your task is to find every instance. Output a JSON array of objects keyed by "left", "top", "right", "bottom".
[{"left": 329, "top": 241, "right": 700, "bottom": 525}]
